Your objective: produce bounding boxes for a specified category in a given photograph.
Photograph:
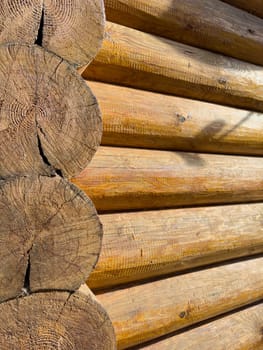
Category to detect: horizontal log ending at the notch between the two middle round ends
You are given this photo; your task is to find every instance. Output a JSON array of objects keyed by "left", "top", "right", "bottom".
[{"left": 72, "top": 147, "right": 263, "bottom": 211}]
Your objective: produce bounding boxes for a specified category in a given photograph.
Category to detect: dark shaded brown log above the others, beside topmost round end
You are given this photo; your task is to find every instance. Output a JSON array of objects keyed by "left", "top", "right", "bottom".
[{"left": 105, "top": 0, "right": 263, "bottom": 65}]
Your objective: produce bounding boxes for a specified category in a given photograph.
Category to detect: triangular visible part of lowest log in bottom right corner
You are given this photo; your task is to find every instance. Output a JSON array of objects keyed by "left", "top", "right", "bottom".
[{"left": 140, "top": 304, "right": 263, "bottom": 350}]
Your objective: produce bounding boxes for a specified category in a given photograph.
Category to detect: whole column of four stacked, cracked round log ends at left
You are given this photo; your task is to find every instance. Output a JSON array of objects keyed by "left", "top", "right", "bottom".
[{"left": 0, "top": 0, "right": 115, "bottom": 350}]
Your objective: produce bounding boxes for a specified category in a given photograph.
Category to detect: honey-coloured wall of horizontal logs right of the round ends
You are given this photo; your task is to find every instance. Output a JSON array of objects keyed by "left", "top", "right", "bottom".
[{"left": 80, "top": 0, "right": 263, "bottom": 350}]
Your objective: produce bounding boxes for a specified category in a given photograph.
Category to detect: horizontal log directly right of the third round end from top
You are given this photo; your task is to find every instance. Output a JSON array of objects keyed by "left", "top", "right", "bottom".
[{"left": 88, "top": 204, "right": 263, "bottom": 289}]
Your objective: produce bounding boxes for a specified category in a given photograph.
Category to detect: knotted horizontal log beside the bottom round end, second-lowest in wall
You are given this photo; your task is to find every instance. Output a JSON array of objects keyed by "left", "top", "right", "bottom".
[{"left": 97, "top": 258, "right": 263, "bottom": 349}]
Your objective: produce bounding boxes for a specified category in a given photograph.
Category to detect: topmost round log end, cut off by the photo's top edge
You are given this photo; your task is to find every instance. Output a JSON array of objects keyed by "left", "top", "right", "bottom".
[{"left": 0, "top": 0, "right": 105, "bottom": 66}]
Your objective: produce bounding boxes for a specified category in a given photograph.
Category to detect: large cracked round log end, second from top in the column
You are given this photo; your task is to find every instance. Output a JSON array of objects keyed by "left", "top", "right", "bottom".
[{"left": 0, "top": 44, "right": 102, "bottom": 178}]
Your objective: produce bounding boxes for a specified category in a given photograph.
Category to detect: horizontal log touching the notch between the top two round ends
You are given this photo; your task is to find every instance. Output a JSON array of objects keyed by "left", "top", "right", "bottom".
[{"left": 82, "top": 22, "right": 263, "bottom": 112}]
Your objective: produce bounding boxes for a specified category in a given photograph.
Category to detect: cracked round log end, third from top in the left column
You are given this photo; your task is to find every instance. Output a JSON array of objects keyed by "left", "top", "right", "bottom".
[{"left": 0, "top": 176, "right": 102, "bottom": 301}]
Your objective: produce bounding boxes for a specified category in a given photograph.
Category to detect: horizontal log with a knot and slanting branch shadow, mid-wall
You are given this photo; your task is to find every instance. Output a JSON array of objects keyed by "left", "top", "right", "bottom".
[{"left": 89, "top": 82, "right": 263, "bottom": 155}]
